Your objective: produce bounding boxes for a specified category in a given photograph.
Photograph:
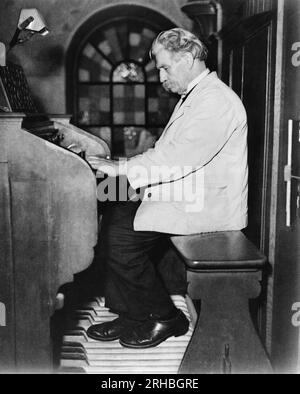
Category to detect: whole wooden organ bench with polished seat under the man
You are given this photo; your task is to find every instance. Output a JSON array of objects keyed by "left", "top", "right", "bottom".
[{"left": 171, "top": 231, "right": 272, "bottom": 374}]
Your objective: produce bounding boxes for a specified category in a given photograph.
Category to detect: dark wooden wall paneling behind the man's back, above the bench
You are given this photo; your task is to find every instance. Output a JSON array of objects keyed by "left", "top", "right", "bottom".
[{"left": 221, "top": 12, "right": 275, "bottom": 251}]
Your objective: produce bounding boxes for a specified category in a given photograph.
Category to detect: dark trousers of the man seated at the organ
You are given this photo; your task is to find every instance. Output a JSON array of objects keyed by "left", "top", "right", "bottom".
[{"left": 97, "top": 201, "right": 187, "bottom": 320}]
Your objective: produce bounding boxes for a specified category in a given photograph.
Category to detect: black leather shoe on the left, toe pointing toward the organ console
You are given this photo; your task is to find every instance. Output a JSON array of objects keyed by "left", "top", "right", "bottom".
[{"left": 86, "top": 317, "right": 136, "bottom": 341}]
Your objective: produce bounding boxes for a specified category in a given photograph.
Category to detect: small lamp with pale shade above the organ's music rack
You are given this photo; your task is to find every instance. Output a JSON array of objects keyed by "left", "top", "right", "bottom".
[{"left": 0, "top": 8, "right": 49, "bottom": 66}]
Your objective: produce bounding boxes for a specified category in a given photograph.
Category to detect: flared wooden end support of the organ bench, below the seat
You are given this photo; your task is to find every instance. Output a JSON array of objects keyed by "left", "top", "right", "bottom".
[{"left": 179, "top": 271, "right": 272, "bottom": 374}]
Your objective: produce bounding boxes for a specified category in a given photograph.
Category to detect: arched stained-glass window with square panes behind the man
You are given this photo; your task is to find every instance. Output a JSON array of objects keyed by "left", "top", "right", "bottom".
[{"left": 68, "top": 9, "right": 178, "bottom": 157}]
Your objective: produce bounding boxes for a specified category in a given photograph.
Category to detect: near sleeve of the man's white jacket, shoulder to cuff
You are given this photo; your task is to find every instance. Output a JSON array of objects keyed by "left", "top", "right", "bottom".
[{"left": 126, "top": 89, "right": 244, "bottom": 189}]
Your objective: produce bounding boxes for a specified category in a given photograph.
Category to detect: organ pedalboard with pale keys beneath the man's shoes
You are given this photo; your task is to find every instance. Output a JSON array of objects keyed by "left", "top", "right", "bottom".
[{"left": 59, "top": 295, "right": 197, "bottom": 374}]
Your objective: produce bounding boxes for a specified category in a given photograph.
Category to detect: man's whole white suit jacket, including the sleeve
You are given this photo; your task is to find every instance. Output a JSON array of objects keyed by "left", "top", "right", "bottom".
[{"left": 126, "top": 72, "right": 248, "bottom": 234}]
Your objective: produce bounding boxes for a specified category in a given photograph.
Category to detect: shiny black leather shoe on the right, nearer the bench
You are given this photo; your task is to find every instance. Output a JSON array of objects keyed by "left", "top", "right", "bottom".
[{"left": 120, "top": 310, "right": 189, "bottom": 349}]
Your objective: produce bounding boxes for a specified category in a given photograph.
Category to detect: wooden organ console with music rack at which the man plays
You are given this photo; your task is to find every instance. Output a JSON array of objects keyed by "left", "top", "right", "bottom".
[{"left": 0, "top": 64, "right": 110, "bottom": 372}]
